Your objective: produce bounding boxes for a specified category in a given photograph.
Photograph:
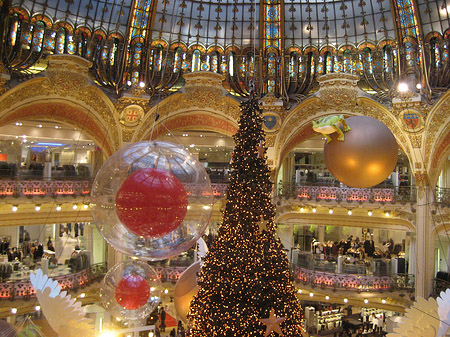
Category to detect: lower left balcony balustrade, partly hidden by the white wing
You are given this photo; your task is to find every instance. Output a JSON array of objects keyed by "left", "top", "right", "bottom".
[{"left": 0, "top": 263, "right": 107, "bottom": 300}]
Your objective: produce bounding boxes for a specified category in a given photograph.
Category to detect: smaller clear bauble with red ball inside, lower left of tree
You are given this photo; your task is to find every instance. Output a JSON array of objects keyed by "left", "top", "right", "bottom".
[{"left": 100, "top": 260, "right": 162, "bottom": 320}]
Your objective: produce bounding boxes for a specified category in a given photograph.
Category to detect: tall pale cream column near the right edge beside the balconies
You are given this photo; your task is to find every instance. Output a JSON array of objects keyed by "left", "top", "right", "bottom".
[{"left": 415, "top": 173, "right": 434, "bottom": 298}]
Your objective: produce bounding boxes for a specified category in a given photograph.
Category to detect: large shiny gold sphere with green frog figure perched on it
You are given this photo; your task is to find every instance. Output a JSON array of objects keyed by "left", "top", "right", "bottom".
[{"left": 323, "top": 116, "right": 398, "bottom": 188}]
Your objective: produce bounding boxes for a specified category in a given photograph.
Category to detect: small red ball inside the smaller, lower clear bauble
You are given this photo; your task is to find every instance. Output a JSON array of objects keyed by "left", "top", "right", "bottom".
[{"left": 115, "top": 275, "right": 150, "bottom": 310}]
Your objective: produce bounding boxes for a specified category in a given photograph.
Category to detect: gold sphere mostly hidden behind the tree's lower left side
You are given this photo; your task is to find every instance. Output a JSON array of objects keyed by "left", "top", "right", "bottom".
[{"left": 173, "top": 261, "right": 201, "bottom": 323}]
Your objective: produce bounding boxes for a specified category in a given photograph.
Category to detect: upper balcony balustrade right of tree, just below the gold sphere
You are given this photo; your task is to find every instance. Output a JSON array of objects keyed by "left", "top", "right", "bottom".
[{"left": 278, "top": 183, "right": 416, "bottom": 203}]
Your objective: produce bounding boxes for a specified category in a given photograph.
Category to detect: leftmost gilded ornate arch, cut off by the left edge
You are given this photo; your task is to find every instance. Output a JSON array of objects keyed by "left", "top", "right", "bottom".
[{"left": 0, "top": 69, "right": 121, "bottom": 156}]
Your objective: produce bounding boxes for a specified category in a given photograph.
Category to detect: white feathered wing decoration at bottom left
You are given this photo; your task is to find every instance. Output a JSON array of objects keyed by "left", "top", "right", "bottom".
[{"left": 30, "top": 269, "right": 95, "bottom": 337}]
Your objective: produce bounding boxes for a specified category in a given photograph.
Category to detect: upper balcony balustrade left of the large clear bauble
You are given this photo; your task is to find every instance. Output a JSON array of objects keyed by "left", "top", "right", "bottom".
[{"left": 0, "top": 180, "right": 91, "bottom": 196}]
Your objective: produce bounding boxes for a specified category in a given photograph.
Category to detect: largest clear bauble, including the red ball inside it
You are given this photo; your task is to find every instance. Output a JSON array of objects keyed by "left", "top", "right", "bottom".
[{"left": 91, "top": 141, "right": 213, "bottom": 261}]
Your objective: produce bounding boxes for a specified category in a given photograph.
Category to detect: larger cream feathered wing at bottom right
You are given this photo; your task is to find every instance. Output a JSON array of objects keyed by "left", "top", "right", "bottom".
[{"left": 387, "top": 297, "right": 440, "bottom": 337}]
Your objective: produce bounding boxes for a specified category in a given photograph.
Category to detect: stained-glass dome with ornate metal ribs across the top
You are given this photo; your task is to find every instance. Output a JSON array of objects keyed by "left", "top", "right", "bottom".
[{"left": 1, "top": 0, "right": 450, "bottom": 104}]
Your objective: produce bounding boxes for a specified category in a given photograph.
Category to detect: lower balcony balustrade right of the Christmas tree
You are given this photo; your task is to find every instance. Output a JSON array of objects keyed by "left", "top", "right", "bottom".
[{"left": 294, "top": 266, "right": 415, "bottom": 291}]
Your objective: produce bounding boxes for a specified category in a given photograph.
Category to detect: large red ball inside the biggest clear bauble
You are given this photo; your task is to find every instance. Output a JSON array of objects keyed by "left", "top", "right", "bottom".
[{"left": 116, "top": 168, "right": 188, "bottom": 238}]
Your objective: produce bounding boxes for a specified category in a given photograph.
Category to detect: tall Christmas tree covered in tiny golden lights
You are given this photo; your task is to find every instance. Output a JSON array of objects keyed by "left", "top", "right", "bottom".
[{"left": 187, "top": 99, "right": 302, "bottom": 337}]
